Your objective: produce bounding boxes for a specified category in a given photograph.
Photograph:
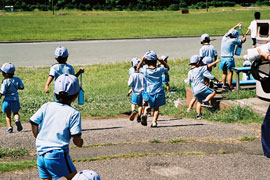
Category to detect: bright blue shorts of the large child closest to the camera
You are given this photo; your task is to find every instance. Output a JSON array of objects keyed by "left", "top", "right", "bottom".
[{"left": 37, "top": 149, "right": 76, "bottom": 179}]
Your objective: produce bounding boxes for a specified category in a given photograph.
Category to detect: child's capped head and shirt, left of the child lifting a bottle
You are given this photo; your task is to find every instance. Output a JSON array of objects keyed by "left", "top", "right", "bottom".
[{"left": 200, "top": 34, "right": 218, "bottom": 61}]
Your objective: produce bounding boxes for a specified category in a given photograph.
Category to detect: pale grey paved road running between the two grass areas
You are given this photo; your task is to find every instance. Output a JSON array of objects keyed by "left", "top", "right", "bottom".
[{"left": 0, "top": 36, "right": 251, "bottom": 66}]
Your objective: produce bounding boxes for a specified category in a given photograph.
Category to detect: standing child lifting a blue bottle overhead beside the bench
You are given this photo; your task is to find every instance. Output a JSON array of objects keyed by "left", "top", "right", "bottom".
[{"left": 219, "top": 23, "right": 246, "bottom": 91}]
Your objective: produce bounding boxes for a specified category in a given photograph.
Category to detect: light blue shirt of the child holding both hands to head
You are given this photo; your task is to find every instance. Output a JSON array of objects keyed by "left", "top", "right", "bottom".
[{"left": 140, "top": 66, "right": 168, "bottom": 95}]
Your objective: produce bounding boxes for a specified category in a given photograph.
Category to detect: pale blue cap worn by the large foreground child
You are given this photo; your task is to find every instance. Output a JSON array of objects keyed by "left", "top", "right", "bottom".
[{"left": 54, "top": 74, "right": 80, "bottom": 96}]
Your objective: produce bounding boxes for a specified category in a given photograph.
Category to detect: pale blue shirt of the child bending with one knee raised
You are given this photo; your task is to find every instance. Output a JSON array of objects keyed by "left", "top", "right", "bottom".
[{"left": 188, "top": 66, "right": 214, "bottom": 95}]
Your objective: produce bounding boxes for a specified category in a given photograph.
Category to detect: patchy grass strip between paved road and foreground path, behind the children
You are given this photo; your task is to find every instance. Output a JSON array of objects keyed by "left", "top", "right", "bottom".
[{"left": 0, "top": 59, "right": 262, "bottom": 126}]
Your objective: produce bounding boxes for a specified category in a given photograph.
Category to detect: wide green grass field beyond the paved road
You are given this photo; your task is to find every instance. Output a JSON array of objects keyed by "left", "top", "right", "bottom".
[{"left": 0, "top": 7, "right": 270, "bottom": 41}]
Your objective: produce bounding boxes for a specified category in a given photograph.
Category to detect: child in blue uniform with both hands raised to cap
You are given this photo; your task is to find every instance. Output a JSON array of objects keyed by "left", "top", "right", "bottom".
[{"left": 137, "top": 50, "right": 169, "bottom": 127}]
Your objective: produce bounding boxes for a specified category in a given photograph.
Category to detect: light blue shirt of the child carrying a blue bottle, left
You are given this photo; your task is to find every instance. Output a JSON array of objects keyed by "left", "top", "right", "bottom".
[{"left": 49, "top": 63, "right": 75, "bottom": 80}]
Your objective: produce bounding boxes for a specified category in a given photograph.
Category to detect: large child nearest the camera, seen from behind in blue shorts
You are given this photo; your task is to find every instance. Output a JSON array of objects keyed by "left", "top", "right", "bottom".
[{"left": 29, "top": 74, "right": 83, "bottom": 179}]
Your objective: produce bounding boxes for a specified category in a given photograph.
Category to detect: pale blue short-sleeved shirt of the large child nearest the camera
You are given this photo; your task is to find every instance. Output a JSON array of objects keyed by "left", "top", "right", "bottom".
[{"left": 30, "top": 102, "right": 81, "bottom": 155}]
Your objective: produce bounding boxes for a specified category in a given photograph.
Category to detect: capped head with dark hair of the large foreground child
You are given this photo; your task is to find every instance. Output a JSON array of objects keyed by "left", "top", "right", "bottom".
[{"left": 54, "top": 74, "right": 80, "bottom": 105}]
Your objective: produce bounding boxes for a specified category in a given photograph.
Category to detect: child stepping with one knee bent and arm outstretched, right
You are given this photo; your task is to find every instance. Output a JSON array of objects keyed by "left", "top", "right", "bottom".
[{"left": 188, "top": 55, "right": 220, "bottom": 119}]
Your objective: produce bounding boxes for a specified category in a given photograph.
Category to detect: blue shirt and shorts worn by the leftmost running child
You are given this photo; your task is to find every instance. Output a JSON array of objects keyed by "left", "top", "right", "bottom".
[{"left": 0, "top": 77, "right": 24, "bottom": 113}]
